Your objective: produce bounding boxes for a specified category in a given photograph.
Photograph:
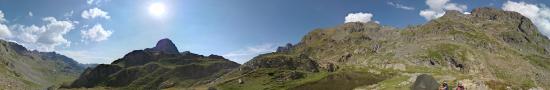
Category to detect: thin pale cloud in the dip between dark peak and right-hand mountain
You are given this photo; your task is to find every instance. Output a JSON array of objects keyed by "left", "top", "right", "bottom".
[{"left": 222, "top": 44, "right": 278, "bottom": 64}]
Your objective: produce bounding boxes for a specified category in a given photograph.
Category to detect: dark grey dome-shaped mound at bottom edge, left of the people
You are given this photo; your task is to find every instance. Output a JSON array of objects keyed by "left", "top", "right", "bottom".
[{"left": 411, "top": 74, "right": 439, "bottom": 90}]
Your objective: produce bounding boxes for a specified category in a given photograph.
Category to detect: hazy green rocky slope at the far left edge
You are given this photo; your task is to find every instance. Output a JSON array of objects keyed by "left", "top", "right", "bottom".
[{"left": 0, "top": 40, "right": 84, "bottom": 90}]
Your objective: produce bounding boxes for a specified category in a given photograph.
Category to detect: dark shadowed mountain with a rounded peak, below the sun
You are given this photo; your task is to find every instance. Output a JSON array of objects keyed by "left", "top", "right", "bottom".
[{"left": 62, "top": 39, "right": 240, "bottom": 90}]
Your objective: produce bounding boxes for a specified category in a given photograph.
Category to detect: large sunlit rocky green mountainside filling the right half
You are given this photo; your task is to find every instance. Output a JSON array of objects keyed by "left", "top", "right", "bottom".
[{"left": 215, "top": 8, "right": 550, "bottom": 90}]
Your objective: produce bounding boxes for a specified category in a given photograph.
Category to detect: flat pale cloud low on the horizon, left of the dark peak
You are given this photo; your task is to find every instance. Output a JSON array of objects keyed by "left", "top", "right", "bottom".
[{"left": 59, "top": 50, "right": 114, "bottom": 63}]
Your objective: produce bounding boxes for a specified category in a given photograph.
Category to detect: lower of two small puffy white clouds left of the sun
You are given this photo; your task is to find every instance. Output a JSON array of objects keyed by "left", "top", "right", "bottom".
[{"left": 81, "top": 24, "right": 113, "bottom": 42}]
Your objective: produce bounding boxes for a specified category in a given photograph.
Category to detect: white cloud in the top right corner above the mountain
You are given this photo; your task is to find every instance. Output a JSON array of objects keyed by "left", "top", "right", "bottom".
[{"left": 502, "top": 1, "right": 550, "bottom": 37}]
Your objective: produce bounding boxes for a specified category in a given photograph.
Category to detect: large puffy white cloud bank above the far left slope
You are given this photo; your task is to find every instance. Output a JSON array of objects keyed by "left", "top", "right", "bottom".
[{"left": 11, "top": 17, "right": 74, "bottom": 51}]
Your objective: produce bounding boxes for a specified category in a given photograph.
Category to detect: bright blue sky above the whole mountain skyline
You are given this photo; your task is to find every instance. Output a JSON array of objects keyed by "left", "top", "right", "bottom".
[{"left": 0, "top": 0, "right": 550, "bottom": 63}]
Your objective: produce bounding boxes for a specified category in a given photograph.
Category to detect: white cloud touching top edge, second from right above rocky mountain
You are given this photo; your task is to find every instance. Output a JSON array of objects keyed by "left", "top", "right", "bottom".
[{"left": 419, "top": 0, "right": 468, "bottom": 20}]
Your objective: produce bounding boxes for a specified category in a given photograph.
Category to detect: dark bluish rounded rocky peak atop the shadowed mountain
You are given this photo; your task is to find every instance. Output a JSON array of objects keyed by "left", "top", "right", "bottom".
[{"left": 150, "top": 38, "right": 179, "bottom": 54}]
